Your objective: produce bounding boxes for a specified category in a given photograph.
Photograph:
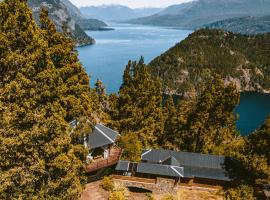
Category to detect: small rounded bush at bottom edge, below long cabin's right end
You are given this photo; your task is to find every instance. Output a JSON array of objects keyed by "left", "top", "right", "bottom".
[{"left": 225, "top": 185, "right": 255, "bottom": 200}]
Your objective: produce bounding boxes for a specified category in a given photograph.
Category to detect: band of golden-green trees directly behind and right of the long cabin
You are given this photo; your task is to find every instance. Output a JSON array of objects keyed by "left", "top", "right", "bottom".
[{"left": 109, "top": 57, "right": 270, "bottom": 200}]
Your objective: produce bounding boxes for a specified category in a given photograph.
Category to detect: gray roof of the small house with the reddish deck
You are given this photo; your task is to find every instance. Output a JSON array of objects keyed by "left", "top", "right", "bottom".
[{"left": 88, "top": 124, "right": 119, "bottom": 148}]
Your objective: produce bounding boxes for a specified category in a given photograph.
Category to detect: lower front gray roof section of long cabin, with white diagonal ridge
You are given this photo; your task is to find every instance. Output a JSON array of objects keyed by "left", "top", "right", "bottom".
[{"left": 137, "top": 163, "right": 184, "bottom": 177}]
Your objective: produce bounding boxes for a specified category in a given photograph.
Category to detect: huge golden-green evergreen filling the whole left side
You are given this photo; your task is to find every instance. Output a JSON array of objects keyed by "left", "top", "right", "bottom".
[{"left": 0, "top": 0, "right": 94, "bottom": 199}]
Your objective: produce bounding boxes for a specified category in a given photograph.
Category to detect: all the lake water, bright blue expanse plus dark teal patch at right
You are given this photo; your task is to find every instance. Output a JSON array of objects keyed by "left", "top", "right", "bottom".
[{"left": 78, "top": 24, "right": 270, "bottom": 135}]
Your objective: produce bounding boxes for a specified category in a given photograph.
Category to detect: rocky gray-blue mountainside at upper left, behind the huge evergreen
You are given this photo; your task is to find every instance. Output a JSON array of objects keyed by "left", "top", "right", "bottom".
[{"left": 27, "top": 0, "right": 107, "bottom": 46}]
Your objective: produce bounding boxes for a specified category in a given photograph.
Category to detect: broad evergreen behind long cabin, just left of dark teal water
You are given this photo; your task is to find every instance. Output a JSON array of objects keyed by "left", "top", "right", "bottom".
[{"left": 181, "top": 75, "right": 240, "bottom": 153}]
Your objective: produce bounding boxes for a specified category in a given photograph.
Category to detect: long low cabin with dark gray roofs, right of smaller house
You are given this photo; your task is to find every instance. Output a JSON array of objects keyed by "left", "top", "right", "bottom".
[{"left": 116, "top": 150, "right": 232, "bottom": 186}]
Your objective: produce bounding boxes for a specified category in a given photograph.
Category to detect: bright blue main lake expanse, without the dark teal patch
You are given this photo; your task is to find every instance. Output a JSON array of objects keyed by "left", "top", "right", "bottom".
[{"left": 78, "top": 24, "right": 192, "bottom": 93}]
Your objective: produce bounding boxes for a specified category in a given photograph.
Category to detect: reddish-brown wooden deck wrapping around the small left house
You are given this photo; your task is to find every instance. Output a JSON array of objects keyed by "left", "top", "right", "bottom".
[{"left": 85, "top": 147, "right": 122, "bottom": 172}]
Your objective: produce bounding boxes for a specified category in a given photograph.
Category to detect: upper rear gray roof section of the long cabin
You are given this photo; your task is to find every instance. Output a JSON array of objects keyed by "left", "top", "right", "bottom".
[{"left": 142, "top": 150, "right": 231, "bottom": 181}]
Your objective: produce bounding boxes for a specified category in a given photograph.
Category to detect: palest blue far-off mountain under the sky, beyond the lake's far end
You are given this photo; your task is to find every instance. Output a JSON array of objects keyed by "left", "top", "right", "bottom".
[{"left": 80, "top": 5, "right": 161, "bottom": 21}]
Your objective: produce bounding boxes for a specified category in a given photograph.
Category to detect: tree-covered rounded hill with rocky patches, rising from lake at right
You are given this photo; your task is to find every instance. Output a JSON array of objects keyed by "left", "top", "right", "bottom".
[{"left": 149, "top": 29, "right": 270, "bottom": 96}]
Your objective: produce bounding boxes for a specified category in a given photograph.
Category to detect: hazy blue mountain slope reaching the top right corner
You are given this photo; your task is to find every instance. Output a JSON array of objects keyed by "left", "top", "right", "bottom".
[{"left": 128, "top": 0, "right": 270, "bottom": 29}]
